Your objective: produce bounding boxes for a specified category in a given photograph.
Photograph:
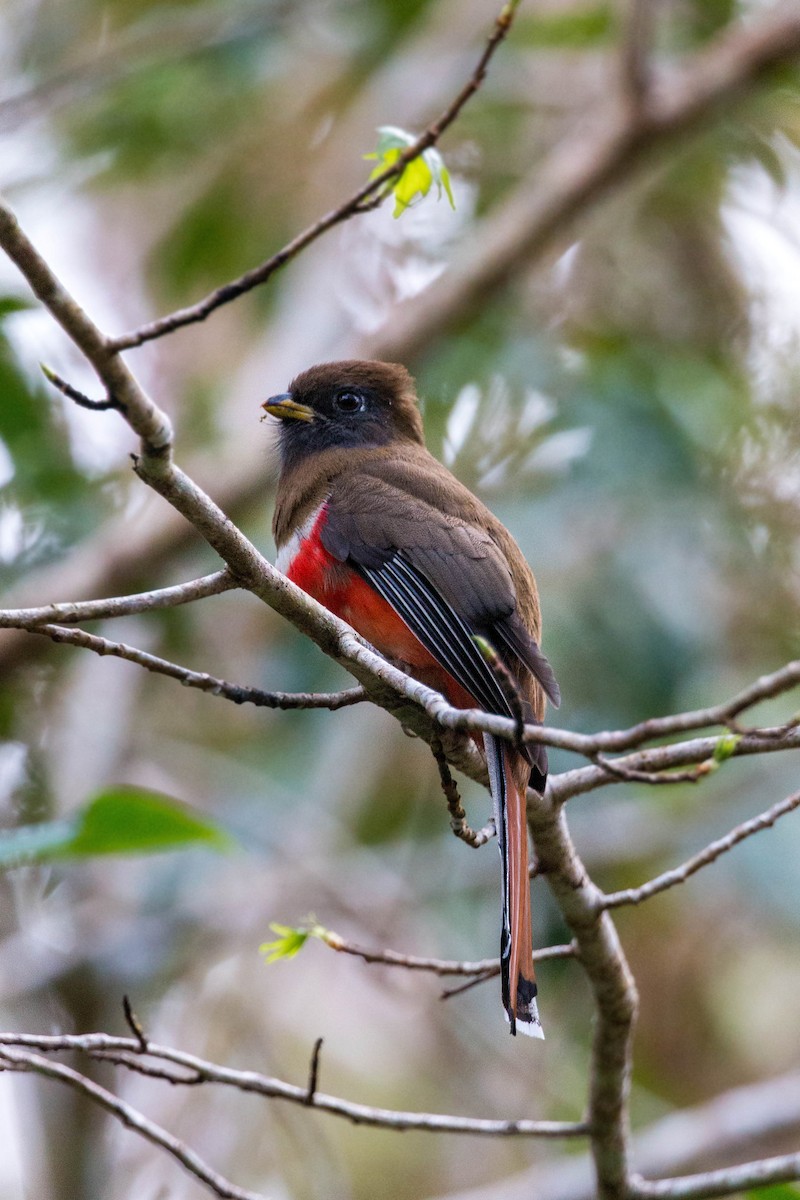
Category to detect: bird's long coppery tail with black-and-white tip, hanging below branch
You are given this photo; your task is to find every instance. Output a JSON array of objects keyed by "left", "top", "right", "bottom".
[{"left": 483, "top": 733, "right": 545, "bottom": 1038}]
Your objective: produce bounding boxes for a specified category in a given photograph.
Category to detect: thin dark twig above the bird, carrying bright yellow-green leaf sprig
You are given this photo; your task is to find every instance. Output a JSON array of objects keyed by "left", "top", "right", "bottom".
[{"left": 108, "top": 0, "right": 518, "bottom": 352}]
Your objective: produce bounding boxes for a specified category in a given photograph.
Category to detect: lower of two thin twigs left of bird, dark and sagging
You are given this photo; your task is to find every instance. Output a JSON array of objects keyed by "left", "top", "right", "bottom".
[{"left": 17, "top": 624, "right": 367, "bottom": 712}]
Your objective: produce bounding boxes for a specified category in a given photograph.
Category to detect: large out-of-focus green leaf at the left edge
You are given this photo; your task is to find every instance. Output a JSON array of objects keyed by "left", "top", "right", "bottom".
[{"left": 0, "top": 786, "right": 233, "bottom": 869}]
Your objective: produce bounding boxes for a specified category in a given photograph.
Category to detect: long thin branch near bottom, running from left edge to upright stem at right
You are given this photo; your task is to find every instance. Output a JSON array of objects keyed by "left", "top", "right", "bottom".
[{"left": 0, "top": 1033, "right": 588, "bottom": 1138}]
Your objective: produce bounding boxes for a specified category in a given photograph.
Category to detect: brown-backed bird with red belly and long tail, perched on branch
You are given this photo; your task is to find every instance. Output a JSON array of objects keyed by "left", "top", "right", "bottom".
[{"left": 261, "top": 359, "right": 560, "bottom": 1038}]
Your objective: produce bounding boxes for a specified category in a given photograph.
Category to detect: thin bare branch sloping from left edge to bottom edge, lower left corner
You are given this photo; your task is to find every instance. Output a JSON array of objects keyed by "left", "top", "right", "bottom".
[{"left": 0, "top": 1043, "right": 264, "bottom": 1200}]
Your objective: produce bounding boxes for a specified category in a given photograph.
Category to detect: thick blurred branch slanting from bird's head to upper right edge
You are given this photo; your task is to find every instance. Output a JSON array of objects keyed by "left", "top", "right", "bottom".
[{"left": 360, "top": 2, "right": 800, "bottom": 362}]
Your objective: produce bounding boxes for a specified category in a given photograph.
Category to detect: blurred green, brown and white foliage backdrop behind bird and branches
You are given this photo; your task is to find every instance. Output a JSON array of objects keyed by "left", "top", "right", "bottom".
[{"left": 0, "top": 0, "right": 800, "bottom": 1200}]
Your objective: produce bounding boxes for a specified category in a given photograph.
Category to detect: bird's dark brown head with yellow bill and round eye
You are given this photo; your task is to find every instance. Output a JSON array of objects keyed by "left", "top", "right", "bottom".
[{"left": 263, "top": 359, "right": 423, "bottom": 466}]
